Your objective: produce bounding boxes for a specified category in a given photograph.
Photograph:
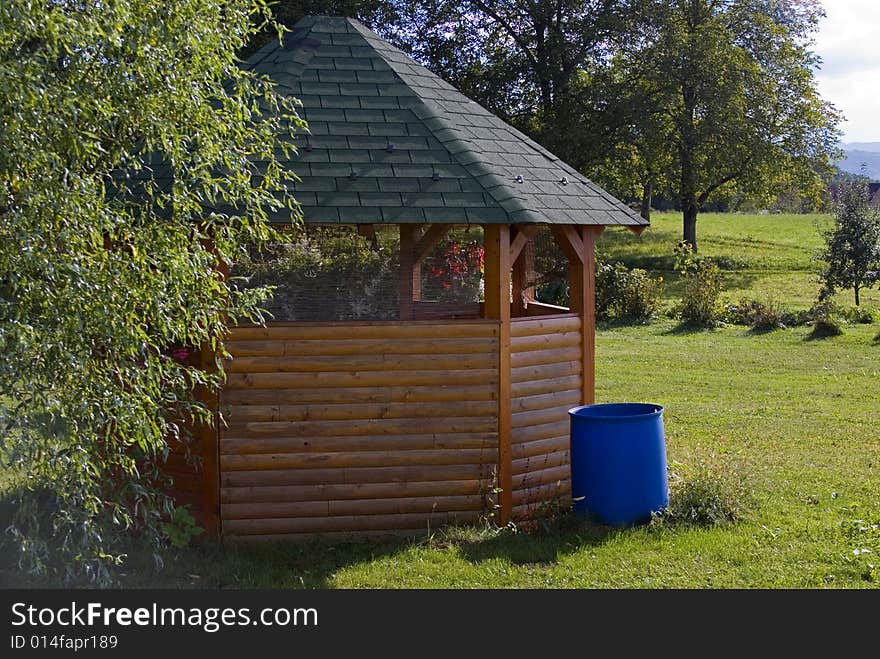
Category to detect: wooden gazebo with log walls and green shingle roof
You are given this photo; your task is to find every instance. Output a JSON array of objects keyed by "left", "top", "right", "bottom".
[{"left": 170, "top": 17, "right": 647, "bottom": 538}]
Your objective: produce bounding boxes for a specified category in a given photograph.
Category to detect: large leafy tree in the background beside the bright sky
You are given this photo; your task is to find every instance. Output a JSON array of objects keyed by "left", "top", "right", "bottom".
[{"left": 617, "top": 0, "right": 839, "bottom": 248}]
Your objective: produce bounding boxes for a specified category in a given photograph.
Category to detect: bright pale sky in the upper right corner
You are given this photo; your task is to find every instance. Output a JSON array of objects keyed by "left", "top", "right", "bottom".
[{"left": 815, "top": 0, "right": 880, "bottom": 143}]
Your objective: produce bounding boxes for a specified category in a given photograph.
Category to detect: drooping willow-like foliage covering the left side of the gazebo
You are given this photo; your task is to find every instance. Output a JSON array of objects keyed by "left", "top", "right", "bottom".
[{"left": 0, "top": 0, "right": 300, "bottom": 584}]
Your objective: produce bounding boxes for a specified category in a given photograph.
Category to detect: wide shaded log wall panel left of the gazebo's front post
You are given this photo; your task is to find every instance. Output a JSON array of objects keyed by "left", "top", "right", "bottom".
[{"left": 220, "top": 321, "right": 498, "bottom": 538}]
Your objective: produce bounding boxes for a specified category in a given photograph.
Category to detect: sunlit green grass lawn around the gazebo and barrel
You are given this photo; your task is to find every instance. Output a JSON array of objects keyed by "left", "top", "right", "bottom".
[{"left": 0, "top": 215, "right": 880, "bottom": 588}]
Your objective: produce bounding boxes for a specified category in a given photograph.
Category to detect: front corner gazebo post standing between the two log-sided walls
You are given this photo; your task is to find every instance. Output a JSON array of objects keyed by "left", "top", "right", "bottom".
[{"left": 483, "top": 224, "right": 513, "bottom": 525}]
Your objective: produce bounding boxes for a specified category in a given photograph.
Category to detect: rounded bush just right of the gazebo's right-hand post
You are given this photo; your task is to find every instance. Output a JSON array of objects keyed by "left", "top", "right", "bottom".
[{"left": 596, "top": 263, "right": 663, "bottom": 322}]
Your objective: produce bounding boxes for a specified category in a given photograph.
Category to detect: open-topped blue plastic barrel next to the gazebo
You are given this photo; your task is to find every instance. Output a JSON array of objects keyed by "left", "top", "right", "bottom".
[{"left": 568, "top": 403, "right": 669, "bottom": 526}]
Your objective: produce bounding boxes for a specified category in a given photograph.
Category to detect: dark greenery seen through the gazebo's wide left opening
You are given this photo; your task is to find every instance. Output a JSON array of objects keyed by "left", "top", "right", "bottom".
[{"left": 232, "top": 226, "right": 399, "bottom": 321}]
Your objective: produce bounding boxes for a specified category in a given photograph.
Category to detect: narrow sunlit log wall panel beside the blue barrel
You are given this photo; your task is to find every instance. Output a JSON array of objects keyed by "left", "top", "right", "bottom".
[{"left": 510, "top": 314, "right": 583, "bottom": 519}]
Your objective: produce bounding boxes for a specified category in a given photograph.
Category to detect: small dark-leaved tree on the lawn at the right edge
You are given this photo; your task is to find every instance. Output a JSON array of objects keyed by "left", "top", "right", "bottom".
[{"left": 820, "top": 181, "right": 880, "bottom": 306}]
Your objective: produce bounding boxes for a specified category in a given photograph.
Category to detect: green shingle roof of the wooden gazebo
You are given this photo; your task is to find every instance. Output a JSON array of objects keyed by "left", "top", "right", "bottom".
[{"left": 246, "top": 16, "right": 648, "bottom": 226}]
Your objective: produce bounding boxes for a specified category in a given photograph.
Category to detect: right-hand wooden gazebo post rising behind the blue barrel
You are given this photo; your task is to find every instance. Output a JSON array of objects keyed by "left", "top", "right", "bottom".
[{"left": 553, "top": 226, "right": 605, "bottom": 405}]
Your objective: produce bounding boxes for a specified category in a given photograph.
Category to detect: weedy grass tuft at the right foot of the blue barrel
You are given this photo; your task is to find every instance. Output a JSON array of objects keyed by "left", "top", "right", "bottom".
[{"left": 660, "top": 462, "right": 752, "bottom": 526}]
